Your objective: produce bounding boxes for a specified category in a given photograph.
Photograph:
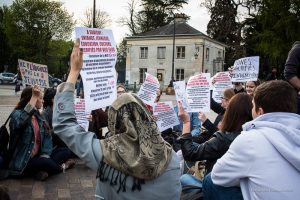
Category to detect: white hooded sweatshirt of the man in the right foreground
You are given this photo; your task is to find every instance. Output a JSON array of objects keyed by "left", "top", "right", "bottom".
[{"left": 211, "top": 112, "right": 300, "bottom": 200}]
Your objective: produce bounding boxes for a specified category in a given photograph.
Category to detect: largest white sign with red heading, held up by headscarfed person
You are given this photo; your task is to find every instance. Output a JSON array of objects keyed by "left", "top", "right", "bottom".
[{"left": 75, "top": 27, "right": 117, "bottom": 112}]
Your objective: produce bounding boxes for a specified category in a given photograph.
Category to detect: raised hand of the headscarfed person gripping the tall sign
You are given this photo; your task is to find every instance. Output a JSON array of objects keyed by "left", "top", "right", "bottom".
[{"left": 67, "top": 39, "right": 83, "bottom": 85}]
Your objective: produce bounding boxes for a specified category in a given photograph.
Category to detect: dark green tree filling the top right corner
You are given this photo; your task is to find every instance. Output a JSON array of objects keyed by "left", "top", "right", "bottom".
[{"left": 252, "top": 0, "right": 300, "bottom": 69}]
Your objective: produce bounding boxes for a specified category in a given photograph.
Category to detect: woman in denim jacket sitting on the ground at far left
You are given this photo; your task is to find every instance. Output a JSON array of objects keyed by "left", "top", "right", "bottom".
[{"left": 8, "top": 85, "right": 73, "bottom": 181}]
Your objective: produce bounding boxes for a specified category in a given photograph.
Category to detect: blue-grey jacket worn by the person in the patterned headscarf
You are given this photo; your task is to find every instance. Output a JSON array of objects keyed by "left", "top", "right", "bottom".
[{"left": 53, "top": 83, "right": 181, "bottom": 200}]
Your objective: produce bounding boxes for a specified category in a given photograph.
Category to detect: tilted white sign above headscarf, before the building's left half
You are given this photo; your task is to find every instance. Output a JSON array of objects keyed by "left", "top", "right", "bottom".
[{"left": 138, "top": 73, "right": 159, "bottom": 106}]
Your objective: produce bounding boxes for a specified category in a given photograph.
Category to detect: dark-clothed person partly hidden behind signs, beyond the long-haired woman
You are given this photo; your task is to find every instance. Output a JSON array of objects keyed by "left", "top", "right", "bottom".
[{"left": 195, "top": 88, "right": 235, "bottom": 143}]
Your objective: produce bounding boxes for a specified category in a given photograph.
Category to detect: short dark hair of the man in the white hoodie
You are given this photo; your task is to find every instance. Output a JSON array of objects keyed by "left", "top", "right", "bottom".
[{"left": 254, "top": 80, "right": 297, "bottom": 113}]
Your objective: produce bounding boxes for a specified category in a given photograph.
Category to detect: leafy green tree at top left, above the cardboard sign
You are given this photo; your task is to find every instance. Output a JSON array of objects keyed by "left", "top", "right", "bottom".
[{"left": 5, "top": 0, "right": 74, "bottom": 66}]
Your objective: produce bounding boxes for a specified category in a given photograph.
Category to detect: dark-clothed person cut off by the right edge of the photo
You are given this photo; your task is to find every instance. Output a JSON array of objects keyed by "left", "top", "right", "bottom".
[{"left": 284, "top": 41, "right": 300, "bottom": 115}]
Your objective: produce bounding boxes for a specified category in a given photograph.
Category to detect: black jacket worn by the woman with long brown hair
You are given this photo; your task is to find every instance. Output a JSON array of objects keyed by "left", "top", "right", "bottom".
[{"left": 179, "top": 132, "right": 240, "bottom": 174}]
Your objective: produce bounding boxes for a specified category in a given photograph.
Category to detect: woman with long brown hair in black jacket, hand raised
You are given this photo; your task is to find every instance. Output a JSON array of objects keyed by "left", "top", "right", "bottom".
[{"left": 179, "top": 93, "right": 252, "bottom": 190}]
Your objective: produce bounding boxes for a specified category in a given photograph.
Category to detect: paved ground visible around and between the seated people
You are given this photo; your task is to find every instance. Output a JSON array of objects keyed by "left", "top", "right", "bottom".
[{"left": 0, "top": 85, "right": 216, "bottom": 200}]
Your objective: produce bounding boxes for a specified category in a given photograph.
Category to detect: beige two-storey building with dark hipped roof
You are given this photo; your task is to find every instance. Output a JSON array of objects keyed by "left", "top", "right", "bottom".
[{"left": 126, "top": 18, "right": 226, "bottom": 87}]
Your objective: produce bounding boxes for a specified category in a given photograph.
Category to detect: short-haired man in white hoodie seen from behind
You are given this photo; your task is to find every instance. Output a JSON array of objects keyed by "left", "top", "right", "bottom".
[{"left": 203, "top": 80, "right": 300, "bottom": 200}]
